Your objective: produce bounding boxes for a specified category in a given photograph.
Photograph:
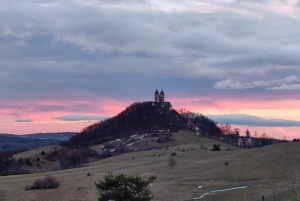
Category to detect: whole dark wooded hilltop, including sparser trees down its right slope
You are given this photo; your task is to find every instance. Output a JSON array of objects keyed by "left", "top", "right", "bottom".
[{"left": 62, "top": 102, "right": 221, "bottom": 146}]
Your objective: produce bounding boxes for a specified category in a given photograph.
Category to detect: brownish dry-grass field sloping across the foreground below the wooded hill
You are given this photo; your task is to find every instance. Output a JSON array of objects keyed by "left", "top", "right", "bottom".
[{"left": 0, "top": 132, "right": 296, "bottom": 201}]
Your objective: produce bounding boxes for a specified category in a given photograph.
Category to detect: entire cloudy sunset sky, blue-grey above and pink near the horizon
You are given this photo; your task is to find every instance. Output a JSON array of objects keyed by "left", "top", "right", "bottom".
[{"left": 0, "top": 0, "right": 300, "bottom": 139}]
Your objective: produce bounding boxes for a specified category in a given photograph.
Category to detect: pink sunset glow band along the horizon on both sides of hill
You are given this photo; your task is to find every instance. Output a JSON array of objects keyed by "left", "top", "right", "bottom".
[{"left": 0, "top": 95, "right": 300, "bottom": 138}]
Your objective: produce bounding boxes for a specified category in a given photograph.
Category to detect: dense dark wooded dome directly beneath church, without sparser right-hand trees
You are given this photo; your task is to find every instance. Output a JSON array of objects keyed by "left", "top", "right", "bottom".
[{"left": 67, "top": 102, "right": 187, "bottom": 146}]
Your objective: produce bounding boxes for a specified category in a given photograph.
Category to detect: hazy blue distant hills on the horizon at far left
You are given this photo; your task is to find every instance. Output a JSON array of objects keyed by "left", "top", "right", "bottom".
[{"left": 0, "top": 132, "right": 76, "bottom": 151}]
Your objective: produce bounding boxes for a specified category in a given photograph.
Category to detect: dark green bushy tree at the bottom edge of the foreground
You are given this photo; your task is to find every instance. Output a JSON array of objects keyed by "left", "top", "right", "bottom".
[{"left": 95, "top": 172, "right": 156, "bottom": 201}]
